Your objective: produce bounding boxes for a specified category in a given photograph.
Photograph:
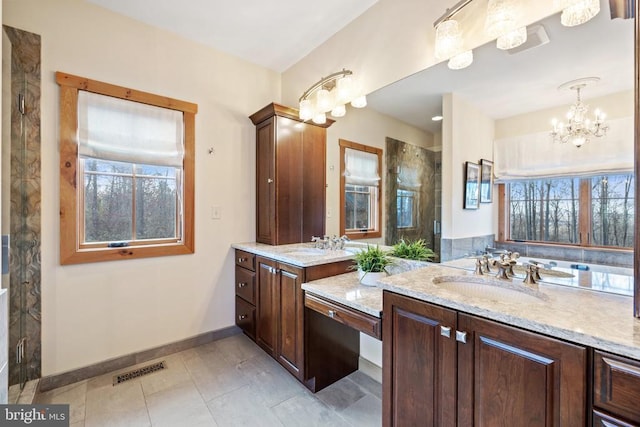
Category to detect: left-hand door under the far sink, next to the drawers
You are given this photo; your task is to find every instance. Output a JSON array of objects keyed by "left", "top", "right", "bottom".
[{"left": 256, "top": 257, "right": 278, "bottom": 356}]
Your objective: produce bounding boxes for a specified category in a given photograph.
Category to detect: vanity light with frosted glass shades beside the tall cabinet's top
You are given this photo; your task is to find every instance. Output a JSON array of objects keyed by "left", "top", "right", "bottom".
[{"left": 298, "top": 68, "right": 367, "bottom": 125}]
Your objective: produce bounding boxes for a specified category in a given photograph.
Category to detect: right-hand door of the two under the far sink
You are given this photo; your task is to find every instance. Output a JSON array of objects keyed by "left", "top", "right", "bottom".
[{"left": 277, "top": 264, "right": 304, "bottom": 379}]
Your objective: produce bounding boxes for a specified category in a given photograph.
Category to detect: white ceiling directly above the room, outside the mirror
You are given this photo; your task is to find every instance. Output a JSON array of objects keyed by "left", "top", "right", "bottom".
[{"left": 87, "top": 0, "right": 378, "bottom": 72}]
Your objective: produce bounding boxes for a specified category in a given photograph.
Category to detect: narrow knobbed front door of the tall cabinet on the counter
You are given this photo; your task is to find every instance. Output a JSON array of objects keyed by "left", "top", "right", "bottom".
[{"left": 256, "top": 118, "right": 277, "bottom": 245}]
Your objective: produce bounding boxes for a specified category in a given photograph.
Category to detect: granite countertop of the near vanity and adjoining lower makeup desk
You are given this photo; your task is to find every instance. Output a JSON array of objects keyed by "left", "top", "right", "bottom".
[{"left": 302, "top": 264, "right": 640, "bottom": 360}]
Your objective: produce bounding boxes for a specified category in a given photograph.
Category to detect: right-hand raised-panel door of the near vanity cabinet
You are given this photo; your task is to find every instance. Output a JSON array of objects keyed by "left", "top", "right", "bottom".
[{"left": 458, "top": 314, "right": 587, "bottom": 427}]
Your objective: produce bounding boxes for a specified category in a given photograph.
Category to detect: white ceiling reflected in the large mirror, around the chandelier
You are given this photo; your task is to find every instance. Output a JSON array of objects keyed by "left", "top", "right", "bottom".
[{"left": 368, "top": 2, "right": 634, "bottom": 132}]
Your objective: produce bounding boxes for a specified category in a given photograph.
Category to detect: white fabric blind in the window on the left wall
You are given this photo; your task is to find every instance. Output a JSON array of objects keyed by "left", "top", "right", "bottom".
[{"left": 78, "top": 90, "right": 184, "bottom": 167}]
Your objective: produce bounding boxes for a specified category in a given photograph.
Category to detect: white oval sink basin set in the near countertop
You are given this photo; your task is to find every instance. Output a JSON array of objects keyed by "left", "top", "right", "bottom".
[{"left": 433, "top": 276, "right": 548, "bottom": 303}]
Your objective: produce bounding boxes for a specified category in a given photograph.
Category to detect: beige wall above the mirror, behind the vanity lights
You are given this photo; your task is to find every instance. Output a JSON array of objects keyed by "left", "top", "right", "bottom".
[{"left": 282, "top": 0, "right": 559, "bottom": 106}]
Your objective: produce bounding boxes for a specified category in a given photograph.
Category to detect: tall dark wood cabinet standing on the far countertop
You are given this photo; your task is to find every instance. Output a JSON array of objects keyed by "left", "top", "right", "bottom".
[{"left": 250, "top": 103, "right": 333, "bottom": 245}]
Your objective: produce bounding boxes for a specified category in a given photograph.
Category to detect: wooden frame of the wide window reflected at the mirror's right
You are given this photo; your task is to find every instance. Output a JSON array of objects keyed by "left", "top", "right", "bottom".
[{"left": 497, "top": 178, "right": 637, "bottom": 252}]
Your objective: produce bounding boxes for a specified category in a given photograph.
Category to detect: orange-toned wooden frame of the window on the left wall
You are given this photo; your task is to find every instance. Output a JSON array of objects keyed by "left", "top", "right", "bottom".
[{"left": 56, "top": 72, "right": 198, "bottom": 265}]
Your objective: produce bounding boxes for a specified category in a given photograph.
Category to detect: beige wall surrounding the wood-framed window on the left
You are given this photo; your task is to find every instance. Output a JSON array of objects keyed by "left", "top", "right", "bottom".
[{"left": 3, "top": 0, "right": 280, "bottom": 375}]
